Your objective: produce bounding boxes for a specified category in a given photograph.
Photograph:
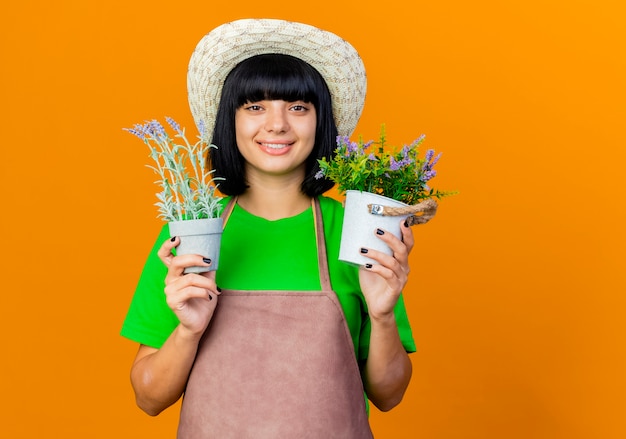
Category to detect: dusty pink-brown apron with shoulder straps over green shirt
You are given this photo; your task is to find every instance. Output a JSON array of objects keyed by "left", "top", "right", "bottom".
[{"left": 178, "top": 198, "right": 372, "bottom": 439}]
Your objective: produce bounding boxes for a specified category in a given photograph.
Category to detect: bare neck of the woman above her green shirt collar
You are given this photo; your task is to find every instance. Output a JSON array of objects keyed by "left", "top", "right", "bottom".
[{"left": 237, "top": 172, "right": 311, "bottom": 221}]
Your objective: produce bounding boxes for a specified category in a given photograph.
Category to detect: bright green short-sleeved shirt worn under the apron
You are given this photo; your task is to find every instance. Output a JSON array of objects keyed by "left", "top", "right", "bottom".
[{"left": 121, "top": 197, "right": 415, "bottom": 360}]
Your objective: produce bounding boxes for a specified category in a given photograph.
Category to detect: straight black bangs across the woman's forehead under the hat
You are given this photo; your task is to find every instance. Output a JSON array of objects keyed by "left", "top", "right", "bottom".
[{"left": 229, "top": 54, "right": 326, "bottom": 107}]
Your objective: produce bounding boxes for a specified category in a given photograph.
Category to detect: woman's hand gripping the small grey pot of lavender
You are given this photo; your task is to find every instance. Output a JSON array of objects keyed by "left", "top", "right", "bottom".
[{"left": 158, "top": 237, "right": 220, "bottom": 338}]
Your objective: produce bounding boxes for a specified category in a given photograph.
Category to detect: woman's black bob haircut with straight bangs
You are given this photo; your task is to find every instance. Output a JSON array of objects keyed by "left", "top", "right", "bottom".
[{"left": 207, "top": 54, "right": 337, "bottom": 197}]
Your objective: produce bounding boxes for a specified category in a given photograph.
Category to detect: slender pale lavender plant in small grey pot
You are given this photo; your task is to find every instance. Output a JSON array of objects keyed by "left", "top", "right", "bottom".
[{"left": 125, "top": 117, "right": 223, "bottom": 273}]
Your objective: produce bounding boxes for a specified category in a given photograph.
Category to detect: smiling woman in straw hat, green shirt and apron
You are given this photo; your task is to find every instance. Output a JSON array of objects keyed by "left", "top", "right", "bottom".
[{"left": 122, "top": 20, "right": 414, "bottom": 438}]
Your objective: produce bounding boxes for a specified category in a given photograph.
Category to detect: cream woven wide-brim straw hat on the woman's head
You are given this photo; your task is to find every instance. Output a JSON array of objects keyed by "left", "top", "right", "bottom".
[{"left": 187, "top": 19, "right": 367, "bottom": 136}]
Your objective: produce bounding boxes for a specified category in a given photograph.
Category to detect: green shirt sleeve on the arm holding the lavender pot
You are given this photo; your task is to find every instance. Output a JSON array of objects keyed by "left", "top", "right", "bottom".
[{"left": 121, "top": 224, "right": 179, "bottom": 349}]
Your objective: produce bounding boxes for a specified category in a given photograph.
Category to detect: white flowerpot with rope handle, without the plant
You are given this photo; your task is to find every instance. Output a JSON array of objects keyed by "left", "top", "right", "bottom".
[{"left": 339, "top": 191, "right": 410, "bottom": 265}]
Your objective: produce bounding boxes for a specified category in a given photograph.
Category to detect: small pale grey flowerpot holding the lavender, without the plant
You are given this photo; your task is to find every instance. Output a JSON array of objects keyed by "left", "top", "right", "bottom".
[{"left": 169, "top": 218, "right": 223, "bottom": 273}]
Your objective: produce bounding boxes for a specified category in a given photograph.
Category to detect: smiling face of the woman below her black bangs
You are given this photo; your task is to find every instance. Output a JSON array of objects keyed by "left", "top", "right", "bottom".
[{"left": 235, "top": 100, "right": 317, "bottom": 180}]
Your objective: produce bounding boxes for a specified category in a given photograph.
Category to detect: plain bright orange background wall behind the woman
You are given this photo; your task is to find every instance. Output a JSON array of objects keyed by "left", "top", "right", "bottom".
[{"left": 0, "top": 0, "right": 626, "bottom": 439}]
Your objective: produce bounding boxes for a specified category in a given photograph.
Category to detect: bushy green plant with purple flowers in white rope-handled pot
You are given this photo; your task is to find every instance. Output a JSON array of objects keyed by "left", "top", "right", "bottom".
[{"left": 316, "top": 125, "right": 454, "bottom": 265}]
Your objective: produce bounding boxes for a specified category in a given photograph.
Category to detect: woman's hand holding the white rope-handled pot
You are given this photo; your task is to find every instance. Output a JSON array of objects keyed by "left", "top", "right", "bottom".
[{"left": 359, "top": 221, "right": 414, "bottom": 319}]
